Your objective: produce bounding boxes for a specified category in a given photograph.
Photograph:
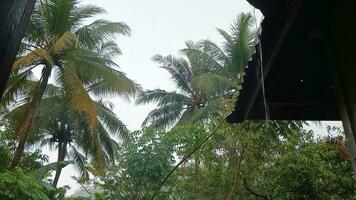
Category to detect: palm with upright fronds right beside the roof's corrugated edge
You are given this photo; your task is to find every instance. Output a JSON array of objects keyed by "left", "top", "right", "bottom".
[{"left": 182, "top": 13, "right": 257, "bottom": 99}]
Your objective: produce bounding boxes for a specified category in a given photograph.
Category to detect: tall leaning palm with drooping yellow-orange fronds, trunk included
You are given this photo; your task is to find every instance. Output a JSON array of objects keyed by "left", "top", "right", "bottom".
[{"left": 7, "top": 0, "right": 138, "bottom": 168}]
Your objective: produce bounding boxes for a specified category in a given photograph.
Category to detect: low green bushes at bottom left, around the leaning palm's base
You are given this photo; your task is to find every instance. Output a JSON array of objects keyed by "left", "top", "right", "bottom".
[{"left": 0, "top": 118, "right": 71, "bottom": 200}]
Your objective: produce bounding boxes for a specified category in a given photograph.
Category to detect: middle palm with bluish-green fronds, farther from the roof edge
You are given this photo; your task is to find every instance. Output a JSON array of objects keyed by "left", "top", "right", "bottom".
[{"left": 136, "top": 55, "right": 221, "bottom": 128}]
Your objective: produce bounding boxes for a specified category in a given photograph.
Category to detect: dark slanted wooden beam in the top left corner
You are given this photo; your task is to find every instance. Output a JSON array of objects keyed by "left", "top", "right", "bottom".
[{"left": 0, "top": 0, "right": 36, "bottom": 98}]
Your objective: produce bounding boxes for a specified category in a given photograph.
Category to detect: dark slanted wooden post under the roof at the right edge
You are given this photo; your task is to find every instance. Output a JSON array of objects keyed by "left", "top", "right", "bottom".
[{"left": 326, "top": 0, "right": 356, "bottom": 177}]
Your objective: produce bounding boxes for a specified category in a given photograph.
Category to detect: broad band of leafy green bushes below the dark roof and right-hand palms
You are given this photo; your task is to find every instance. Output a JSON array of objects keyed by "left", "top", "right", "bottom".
[{"left": 92, "top": 121, "right": 356, "bottom": 199}]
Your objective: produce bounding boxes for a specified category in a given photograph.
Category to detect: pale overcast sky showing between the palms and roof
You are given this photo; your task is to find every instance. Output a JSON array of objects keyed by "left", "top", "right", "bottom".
[{"left": 41, "top": 0, "right": 342, "bottom": 194}]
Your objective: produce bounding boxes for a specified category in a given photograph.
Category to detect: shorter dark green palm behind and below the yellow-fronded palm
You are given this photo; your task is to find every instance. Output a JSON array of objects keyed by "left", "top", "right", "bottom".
[{"left": 34, "top": 96, "right": 129, "bottom": 187}]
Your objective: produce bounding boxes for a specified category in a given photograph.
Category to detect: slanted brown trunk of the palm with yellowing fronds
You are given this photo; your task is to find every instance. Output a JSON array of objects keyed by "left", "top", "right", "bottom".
[{"left": 10, "top": 65, "right": 51, "bottom": 169}]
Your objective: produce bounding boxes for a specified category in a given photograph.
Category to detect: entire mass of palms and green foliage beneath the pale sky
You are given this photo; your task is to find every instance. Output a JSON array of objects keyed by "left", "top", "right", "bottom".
[{"left": 0, "top": 0, "right": 356, "bottom": 200}]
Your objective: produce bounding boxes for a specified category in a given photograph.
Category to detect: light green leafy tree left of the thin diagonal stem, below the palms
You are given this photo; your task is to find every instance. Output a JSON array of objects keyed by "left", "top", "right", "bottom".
[{"left": 96, "top": 128, "right": 176, "bottom": 199}]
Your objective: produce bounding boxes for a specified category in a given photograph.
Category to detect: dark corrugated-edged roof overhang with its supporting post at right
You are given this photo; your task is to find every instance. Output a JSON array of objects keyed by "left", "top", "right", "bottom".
[{"left": 227, "top": 0, "right": 356, "bottom": 173}]
